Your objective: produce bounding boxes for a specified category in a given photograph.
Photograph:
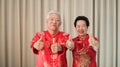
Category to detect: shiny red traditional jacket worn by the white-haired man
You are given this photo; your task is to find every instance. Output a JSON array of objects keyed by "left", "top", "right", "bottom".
[{"left": 31, "top": 31, "right": 69, "bottom": 67}]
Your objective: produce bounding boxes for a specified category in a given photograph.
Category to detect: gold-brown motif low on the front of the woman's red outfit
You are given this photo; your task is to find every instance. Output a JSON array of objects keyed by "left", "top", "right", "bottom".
[{"left": 80, "top": 54, "right": 91, "bottom": 67}]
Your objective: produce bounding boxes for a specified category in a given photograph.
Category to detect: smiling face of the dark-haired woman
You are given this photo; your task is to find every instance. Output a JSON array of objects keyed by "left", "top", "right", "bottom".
[{"left": 76, "top": 20, "right": 88, "bottom": 37}]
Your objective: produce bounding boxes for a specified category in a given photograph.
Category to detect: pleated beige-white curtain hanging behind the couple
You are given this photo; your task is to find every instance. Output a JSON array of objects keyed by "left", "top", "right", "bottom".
[{"left": 0, "top": 0, "right": 120, "bottom": 67}]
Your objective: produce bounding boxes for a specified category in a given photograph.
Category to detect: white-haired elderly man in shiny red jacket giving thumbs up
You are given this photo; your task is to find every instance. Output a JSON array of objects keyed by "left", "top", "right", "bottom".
[{"left": 31, "top": 11, "right": 74, "bottom": 67}]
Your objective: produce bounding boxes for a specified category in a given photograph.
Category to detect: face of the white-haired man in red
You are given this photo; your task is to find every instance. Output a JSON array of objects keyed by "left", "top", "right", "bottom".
[{"left": 47, "top": 13, "right": 61, "bottom": 31}]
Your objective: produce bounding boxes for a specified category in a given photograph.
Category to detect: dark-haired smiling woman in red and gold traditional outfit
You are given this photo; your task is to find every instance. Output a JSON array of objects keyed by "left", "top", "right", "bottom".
[{"left": 72, "top": 16, "right": 98, "bottom": 67}]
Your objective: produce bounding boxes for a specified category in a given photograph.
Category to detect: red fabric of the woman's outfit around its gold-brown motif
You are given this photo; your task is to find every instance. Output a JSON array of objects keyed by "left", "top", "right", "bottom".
[{"left": 72, "top": 35, "right": 97, "bottom": 67}]
